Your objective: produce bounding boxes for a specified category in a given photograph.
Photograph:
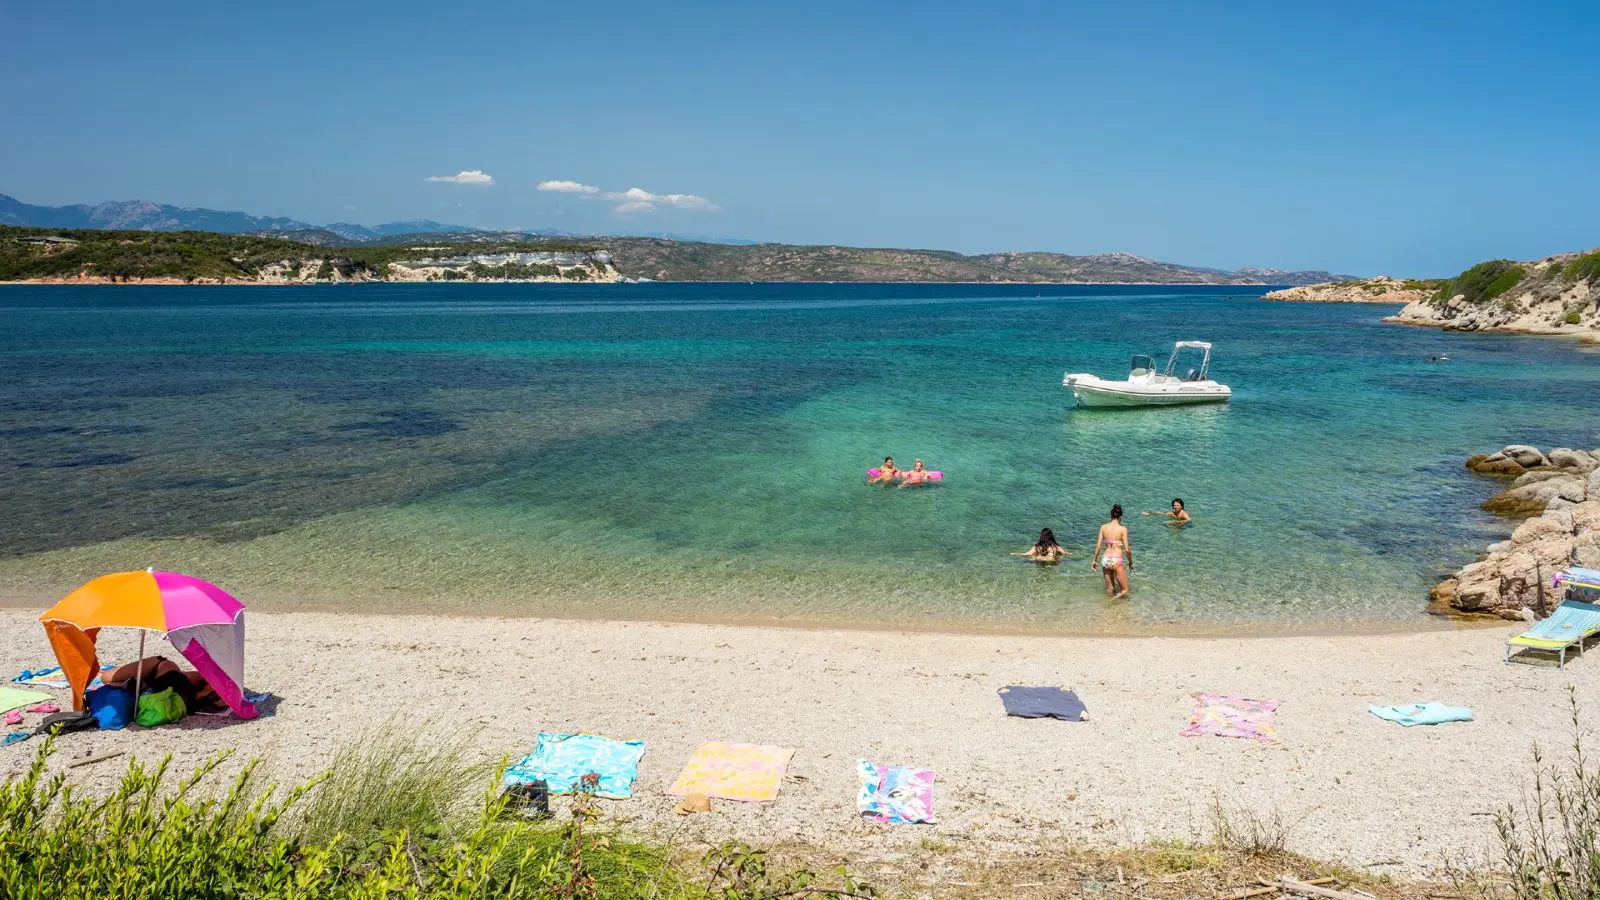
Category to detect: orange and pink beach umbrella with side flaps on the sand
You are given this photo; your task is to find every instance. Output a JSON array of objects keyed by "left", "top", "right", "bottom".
[{"left": 38, "top": 569, "right": 256, "bottom": 719}]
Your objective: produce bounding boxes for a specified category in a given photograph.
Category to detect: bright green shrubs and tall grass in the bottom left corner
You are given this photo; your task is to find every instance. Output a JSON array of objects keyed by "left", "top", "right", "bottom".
[{"left": 0, "top": 727, "right": 877, "bottom": 900}]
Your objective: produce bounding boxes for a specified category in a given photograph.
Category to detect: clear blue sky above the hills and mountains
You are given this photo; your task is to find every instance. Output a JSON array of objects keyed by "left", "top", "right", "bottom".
[{"left": 0, "top": 0, "right": 1600, "bottom": 275}]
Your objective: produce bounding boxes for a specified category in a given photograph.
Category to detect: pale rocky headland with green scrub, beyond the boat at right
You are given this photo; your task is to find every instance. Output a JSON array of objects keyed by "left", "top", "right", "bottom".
[{"left": 1266, "top": 250, "right": 1600, "bottom": 338}]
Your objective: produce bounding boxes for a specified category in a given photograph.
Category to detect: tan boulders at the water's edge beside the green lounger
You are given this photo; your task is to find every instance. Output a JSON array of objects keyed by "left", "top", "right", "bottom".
[{"left": 1429, "top": 444, "right": 1600, "bottom": 618}]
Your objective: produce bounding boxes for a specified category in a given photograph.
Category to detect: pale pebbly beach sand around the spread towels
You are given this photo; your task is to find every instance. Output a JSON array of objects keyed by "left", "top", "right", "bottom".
[{"left": 0, "top": 610, "right": 1600, "bottom": 876}]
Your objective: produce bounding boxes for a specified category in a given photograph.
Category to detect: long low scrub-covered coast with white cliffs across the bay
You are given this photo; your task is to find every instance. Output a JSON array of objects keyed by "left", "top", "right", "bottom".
[{"left": 0, "top": 217, "right": 1338, "bottom": 285}]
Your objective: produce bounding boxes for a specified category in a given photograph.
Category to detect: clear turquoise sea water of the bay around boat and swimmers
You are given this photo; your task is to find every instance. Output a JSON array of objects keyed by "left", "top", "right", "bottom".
[{"left": 0, "top": 283, "right": 1600, "bottom": 631}]
